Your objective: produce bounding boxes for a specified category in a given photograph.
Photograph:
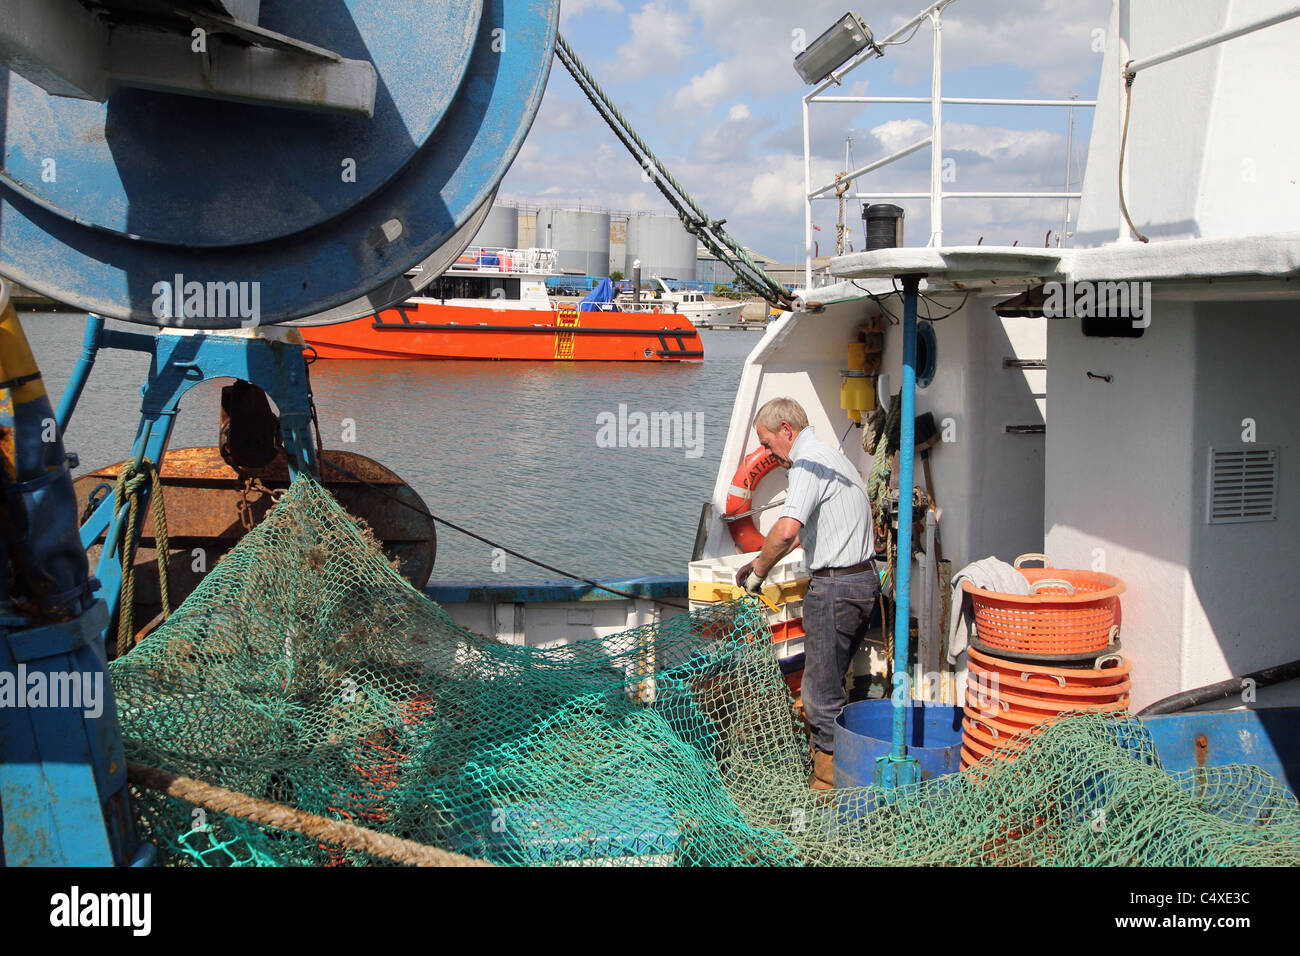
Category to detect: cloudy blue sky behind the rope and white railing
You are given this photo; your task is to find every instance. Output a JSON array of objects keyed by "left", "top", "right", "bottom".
[{"left": 499, "top": 0, "right": 1110, "bottom": 261}]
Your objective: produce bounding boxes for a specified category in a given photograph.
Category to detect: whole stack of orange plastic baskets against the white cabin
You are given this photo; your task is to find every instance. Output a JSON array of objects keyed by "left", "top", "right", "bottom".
[{"left": 962, "top": 554, "right": 1132, "bottom": 767}]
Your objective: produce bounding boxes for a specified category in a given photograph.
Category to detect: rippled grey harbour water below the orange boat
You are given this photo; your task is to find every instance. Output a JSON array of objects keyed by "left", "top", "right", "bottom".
[{"left": 23, "top": 312, "right": 759, "bottom": 580}]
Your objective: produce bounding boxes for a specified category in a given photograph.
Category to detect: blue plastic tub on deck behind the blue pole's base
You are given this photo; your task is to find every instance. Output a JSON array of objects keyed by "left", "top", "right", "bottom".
[{"left": 835, "top": 697, "right": 962, "bottom": 787}]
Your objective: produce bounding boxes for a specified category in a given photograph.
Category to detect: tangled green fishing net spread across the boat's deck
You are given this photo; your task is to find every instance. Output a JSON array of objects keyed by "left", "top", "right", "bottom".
[{"left": 111, "top": 479, "right": 1300, "bottom": 865}]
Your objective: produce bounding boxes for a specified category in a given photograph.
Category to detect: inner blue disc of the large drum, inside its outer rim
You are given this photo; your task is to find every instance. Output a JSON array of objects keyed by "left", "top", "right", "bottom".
[{"left": 4, "top": 0, "right": 482, "bottom": 246}]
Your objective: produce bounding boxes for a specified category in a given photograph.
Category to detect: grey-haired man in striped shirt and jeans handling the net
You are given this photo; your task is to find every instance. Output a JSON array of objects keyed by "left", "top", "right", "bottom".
[{"left": 736, "top": 398, "right": 880, "bottom": 790}]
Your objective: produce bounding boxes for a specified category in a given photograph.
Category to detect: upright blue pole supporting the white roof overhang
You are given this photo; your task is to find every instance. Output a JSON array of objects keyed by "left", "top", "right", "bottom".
[{"left": 876, "top": 276, "right": 920, "bottom": 787}]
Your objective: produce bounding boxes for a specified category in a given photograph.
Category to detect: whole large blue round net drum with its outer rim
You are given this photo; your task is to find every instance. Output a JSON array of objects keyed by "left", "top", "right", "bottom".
[{"left": 0, "top": 0, "right": 559, "bottom": 329}]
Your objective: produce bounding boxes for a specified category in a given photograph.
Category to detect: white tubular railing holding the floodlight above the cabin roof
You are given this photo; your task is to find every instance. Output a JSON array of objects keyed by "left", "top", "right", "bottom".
[{"left": 803, "top": 0, "right": 1097, "bottom": 289}]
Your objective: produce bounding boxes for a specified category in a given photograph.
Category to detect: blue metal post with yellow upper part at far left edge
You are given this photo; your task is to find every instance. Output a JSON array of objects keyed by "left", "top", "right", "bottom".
[{"left": 0, "top": 304, "right": 139, "bottom": 866}]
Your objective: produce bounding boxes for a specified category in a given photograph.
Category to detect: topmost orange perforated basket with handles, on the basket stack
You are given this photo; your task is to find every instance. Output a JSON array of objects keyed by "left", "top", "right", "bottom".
[{"left": 962, "top": 554, "right": 1125, "bottom": 657}]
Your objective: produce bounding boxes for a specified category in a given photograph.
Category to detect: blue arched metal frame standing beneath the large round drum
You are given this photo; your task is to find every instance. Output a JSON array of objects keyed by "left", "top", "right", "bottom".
[{"left": 56, "top": 315, "right": 320, "bottom": 639}]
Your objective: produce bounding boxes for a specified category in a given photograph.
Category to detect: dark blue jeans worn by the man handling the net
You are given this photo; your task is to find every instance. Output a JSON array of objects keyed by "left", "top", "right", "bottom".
[{"left": 803, "top": 571, "right": 880, "bottom": 753}]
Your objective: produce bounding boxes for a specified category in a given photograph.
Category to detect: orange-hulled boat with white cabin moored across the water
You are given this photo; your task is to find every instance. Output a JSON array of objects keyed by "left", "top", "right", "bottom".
[{"left": 299, "top": 248, "right": 705, "bottom": 362}]
